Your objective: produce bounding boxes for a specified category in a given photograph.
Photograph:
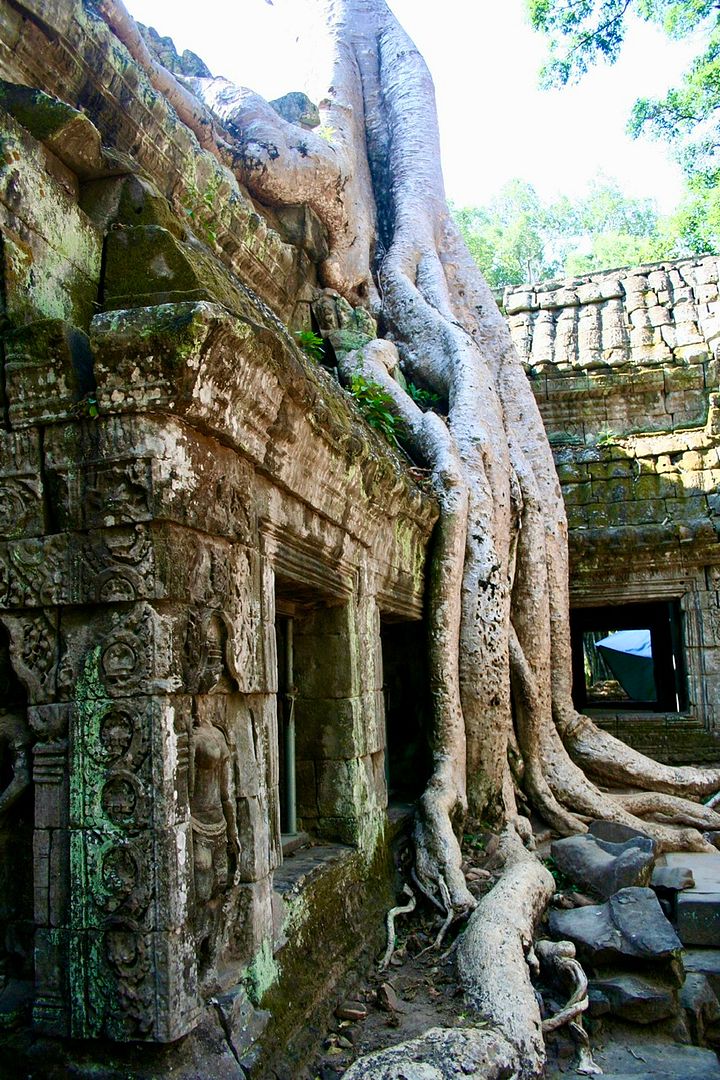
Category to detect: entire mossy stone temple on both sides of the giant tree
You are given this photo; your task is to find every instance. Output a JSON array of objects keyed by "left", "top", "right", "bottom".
[{"left": 0, "top": 0, "right": 720, "bottom": 1077}]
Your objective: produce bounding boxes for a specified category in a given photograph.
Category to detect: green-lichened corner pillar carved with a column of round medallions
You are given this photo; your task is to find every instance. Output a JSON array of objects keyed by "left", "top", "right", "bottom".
[{"left": 61, "top": 604, "right": 199, "bottom": 1041}]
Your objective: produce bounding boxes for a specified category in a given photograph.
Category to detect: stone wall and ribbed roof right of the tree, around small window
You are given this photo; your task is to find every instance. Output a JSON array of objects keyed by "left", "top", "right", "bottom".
[{"left": 505, "top": 257, "right": 720, "bottom": 760}]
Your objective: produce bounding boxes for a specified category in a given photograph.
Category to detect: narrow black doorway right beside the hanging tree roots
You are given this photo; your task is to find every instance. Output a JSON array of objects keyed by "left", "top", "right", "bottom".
[{"left": 380, "top": 620, "right": 432, "bottom": 802}]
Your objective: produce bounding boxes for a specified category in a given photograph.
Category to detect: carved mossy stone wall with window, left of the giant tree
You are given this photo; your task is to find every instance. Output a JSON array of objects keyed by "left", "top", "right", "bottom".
[{"left": 0, "top": 2, "right": 437, "bottom": 1062}]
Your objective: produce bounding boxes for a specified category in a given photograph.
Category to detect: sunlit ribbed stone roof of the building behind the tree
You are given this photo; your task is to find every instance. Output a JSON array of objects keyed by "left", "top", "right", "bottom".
[{"left": 505, "top": 257, "right": 720, "bottom": 445}]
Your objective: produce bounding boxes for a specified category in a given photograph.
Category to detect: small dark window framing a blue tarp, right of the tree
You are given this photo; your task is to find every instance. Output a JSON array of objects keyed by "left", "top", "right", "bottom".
[{"left": 570, "top": 599, "right": 688, "bottom": 713}]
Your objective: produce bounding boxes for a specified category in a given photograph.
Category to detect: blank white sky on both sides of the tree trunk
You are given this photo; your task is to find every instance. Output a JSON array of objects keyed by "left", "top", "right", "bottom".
[{"left": 125, "top": 0, "right": 693, "bottom": 211}]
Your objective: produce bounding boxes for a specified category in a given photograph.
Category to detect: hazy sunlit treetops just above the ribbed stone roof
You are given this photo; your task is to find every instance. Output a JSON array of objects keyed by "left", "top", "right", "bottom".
[{"left": 453, "top": 176, "right": 690, "bottom": 288}]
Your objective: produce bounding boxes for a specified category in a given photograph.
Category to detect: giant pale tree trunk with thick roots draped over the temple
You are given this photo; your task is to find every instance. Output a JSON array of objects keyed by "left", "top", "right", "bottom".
[{"left": 96, "top": 0, "right": 720, "bottom": 1080}]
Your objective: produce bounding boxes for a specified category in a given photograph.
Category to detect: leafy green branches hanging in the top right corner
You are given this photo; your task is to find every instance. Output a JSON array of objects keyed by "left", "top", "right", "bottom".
[{"left": 526, "top": 0, "right": 720, "bottom": 254}]
